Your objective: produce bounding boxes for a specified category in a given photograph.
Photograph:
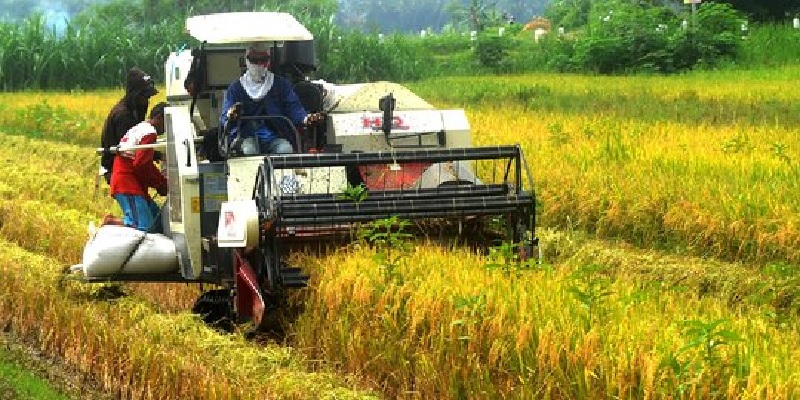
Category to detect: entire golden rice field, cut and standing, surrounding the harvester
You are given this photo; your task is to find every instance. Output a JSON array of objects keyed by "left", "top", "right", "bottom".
[{"left": 0, "top": 68, "right": 800, "bottom": 399}]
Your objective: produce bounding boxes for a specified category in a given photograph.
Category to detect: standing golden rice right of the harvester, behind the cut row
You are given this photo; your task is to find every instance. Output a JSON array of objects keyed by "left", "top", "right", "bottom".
[{"left": 418, "top": 67, "right": 800, "bottom": 263}]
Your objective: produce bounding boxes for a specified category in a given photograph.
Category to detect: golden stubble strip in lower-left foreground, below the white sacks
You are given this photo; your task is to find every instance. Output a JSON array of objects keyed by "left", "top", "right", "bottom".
[{"left": 0, "top": 241, "right": 373, "bottom": 400}]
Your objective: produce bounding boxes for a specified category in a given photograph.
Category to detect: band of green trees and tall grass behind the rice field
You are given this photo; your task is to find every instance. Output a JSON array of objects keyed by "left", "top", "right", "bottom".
[{"left": 0, "top": 0, "right": 798, "bottom": 91}]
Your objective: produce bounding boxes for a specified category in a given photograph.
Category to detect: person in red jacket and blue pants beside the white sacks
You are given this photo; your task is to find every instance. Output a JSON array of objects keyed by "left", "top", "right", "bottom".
[{"left": 111, "top": 102, "right": 167, "bottom": 232}]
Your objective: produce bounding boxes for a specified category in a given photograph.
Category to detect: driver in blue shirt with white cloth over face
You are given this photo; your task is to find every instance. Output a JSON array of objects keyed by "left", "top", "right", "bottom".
[{"left": 220, "top": 43, "right": 322, "bottom": 155}]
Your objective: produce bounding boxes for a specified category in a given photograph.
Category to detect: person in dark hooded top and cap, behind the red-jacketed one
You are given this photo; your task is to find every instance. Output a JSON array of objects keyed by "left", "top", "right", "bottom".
[{"left": 100, "top": 67, "right": 158, "bottom": 184}]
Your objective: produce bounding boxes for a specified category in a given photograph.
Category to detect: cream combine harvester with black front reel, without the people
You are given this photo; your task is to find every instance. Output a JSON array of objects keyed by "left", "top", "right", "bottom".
[{"left": 74, "top": 13, "right": 538, "bottom": 329}]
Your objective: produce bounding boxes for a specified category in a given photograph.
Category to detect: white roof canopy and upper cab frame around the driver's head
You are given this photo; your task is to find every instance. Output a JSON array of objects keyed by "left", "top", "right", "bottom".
[{"left": 166, "top": 12, "right": 316, "bottom": 140}]
